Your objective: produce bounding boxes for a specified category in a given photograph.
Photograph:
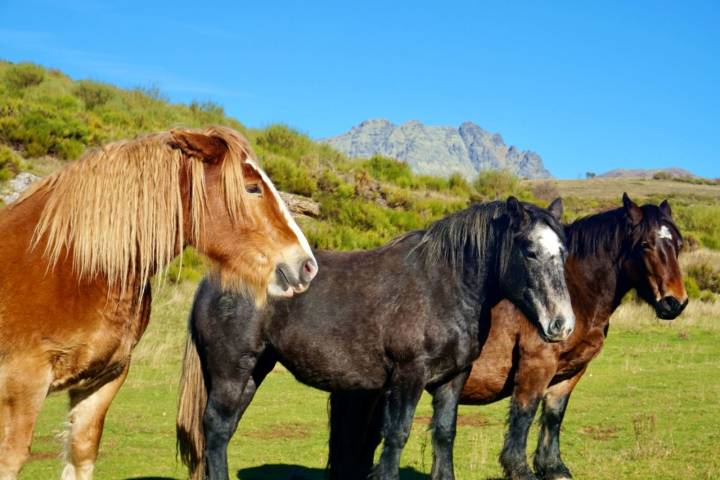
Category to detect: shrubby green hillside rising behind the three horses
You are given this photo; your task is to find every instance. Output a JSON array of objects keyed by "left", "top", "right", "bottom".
[{"left": 0, "top": 61, "right": 720, "bottom": 299}]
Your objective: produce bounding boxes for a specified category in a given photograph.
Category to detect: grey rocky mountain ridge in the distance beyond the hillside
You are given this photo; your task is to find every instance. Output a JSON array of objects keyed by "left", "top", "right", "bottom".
[{"left": 321, "top": 119, "right": 551, "bottom": 179}]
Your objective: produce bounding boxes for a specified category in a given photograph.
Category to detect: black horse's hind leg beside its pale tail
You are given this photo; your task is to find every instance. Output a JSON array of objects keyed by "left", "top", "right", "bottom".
[{"left": 203, "top": 351, "right": 276, "bottom": 480}]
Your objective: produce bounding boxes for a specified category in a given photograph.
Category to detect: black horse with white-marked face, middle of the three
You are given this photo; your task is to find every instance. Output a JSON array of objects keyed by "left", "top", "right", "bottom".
[{"left": 177, "top": 197, "right": 574, "bottom": 480}]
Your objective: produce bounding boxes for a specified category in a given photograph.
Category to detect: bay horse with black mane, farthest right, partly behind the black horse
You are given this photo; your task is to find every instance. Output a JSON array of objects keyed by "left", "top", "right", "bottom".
[{"left": 328, "top": 194, "right": 688, "bottom": 480}]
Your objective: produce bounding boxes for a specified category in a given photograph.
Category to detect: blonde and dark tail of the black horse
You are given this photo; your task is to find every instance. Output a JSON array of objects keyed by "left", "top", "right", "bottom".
[{"left": 175, "top": 327, "right": 207, "bottom": 480}]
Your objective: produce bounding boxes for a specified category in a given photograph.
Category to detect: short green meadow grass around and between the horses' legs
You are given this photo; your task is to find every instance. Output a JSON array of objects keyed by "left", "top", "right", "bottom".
[{"left": 20, "top": 283, "right": 720, "bottom": 480}]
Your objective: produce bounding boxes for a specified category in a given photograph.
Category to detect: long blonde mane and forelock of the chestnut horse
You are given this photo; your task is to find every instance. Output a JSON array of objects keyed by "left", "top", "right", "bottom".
[{"left": 23, "top": 127, "right": 252, "bottom": 291}]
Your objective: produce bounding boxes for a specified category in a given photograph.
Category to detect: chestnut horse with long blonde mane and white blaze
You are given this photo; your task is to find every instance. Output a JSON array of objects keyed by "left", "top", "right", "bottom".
[{"left": 0, "top": 127, "right": 317, "bottom": 479}]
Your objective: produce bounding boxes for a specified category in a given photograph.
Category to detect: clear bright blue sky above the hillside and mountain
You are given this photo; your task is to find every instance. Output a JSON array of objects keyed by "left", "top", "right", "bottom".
[{"left": 0, "top": 0, "right": 720, "bottom": 178}]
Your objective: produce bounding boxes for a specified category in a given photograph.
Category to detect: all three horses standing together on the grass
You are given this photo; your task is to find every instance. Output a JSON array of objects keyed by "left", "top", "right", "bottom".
[{"left": 0, "top": 127, "right": 687, "bottom": 480}]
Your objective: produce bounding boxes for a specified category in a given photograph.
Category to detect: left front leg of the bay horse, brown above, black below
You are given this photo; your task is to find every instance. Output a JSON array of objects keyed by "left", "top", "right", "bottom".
[{"left": 500, "top": 358, "right": 557, "bottom": 480}]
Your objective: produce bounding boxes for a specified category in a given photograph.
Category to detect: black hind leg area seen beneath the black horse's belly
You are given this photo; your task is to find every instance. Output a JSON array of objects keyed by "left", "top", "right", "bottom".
[{"left": 328, "top": 391, "right": 383, "bottom": 480}]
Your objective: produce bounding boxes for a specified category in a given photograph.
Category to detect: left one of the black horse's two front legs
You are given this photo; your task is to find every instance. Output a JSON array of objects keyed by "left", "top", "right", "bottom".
[{"left": 373, "top": 364, "right": 425, "bottom": 480}]
